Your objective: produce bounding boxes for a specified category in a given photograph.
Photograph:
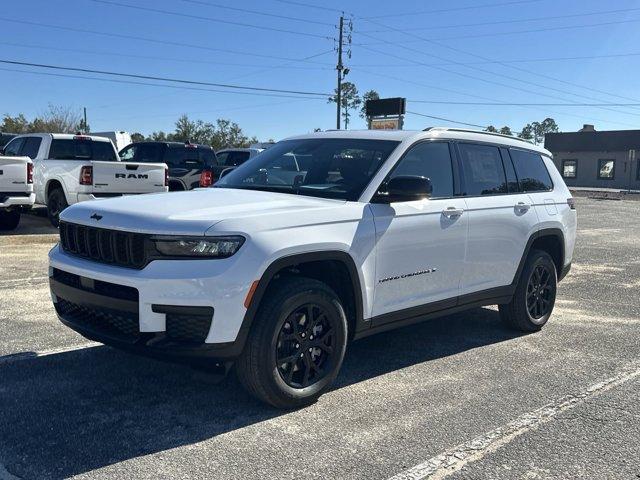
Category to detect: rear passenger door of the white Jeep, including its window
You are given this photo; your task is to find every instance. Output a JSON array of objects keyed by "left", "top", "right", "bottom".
[{"left": 457, "top": 143, "right": 538, "bottom": 295}]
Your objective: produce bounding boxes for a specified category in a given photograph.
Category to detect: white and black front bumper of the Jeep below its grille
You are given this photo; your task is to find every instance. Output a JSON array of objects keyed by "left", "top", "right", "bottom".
[{"left": 49, "top": 245, "right": 252, "bottom": 350}]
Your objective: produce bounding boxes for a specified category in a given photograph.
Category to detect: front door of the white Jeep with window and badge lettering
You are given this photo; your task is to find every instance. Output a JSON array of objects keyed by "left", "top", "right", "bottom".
[{"left": 371, "top": 141, "right": 467, "bottom": 324}]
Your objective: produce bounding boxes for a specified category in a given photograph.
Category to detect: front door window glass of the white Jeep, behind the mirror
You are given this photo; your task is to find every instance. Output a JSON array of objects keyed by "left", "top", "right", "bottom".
[{"left": 390, "top": 142, "right": 453, "bottom": 198}]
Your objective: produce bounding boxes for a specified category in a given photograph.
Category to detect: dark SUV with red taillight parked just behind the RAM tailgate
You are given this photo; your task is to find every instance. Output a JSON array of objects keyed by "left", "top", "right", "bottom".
[{"left": 120, "top": 142, "right": 217, "bottom": 192}]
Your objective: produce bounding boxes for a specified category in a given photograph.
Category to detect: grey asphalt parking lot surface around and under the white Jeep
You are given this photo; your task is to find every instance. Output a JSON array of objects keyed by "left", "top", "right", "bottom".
[{"left": 0, "top": 198, "right": 640, "bottom": 480}]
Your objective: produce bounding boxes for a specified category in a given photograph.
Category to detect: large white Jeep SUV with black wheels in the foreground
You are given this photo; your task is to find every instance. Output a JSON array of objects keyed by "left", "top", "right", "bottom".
[{"left": 49, "top": 128, "right": 576, "bottom": 408}]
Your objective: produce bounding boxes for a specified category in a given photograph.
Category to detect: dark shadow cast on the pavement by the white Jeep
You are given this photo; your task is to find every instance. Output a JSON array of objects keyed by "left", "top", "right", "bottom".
[{"left": 0, "top": 309, "right": 516, "bottom": 478}]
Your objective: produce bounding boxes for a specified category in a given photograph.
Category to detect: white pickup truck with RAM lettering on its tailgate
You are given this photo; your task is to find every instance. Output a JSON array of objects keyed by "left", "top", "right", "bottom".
[{"left": 3, "top": 133, "right": 169, "bottom": 227}]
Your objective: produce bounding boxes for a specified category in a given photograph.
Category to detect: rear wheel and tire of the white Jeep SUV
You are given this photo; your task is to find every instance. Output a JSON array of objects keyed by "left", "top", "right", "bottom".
[{"left": 499, "top": 250, "right": 558, "bottom": 332}]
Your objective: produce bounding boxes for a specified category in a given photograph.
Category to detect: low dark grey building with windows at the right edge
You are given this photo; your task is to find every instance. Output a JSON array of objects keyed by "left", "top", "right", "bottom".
[{"left": 544, "top": 125, "right": 640, "bottom": 190}]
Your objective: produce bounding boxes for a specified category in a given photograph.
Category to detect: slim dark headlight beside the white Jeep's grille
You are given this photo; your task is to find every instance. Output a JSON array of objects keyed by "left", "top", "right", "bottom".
[{"left": 152, "top": 236, "right": 244, "bottom": 258}]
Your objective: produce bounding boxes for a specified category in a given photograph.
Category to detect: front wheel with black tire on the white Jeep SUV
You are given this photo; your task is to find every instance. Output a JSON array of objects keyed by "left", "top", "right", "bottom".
[{"left": 235, "top": 277, "right": 347, "bottom": 409}]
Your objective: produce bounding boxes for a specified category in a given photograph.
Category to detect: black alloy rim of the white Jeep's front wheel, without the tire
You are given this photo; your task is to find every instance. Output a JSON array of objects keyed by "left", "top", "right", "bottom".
[{"left": 276, "top": 304, "right": 335, "bottom": 388}]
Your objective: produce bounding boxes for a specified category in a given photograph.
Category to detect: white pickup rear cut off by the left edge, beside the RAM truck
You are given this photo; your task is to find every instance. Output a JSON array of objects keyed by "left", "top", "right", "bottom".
[{"left": 0, "top": 157, "right": 36, "bottom": 230}]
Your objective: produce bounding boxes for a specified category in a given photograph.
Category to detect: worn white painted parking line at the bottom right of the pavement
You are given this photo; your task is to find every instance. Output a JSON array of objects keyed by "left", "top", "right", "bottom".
[{"left": 389, "top": 362, "right": 640, "bottom": 480}]
